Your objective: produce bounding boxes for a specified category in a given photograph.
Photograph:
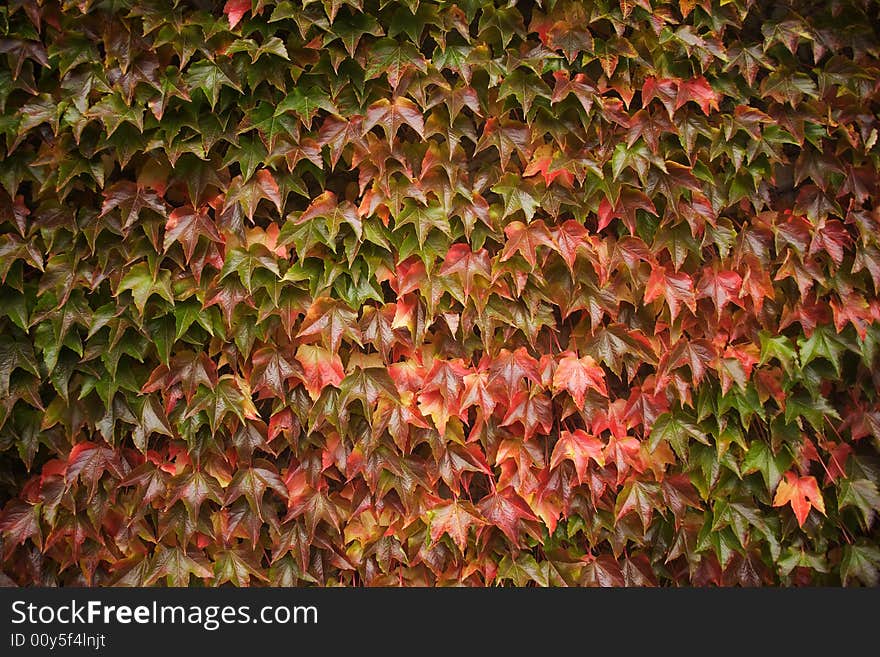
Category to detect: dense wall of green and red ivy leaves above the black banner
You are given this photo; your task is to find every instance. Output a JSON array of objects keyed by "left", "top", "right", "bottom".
[{"left": 0, "top": 0, "right": 880, "bottom": 585}]
